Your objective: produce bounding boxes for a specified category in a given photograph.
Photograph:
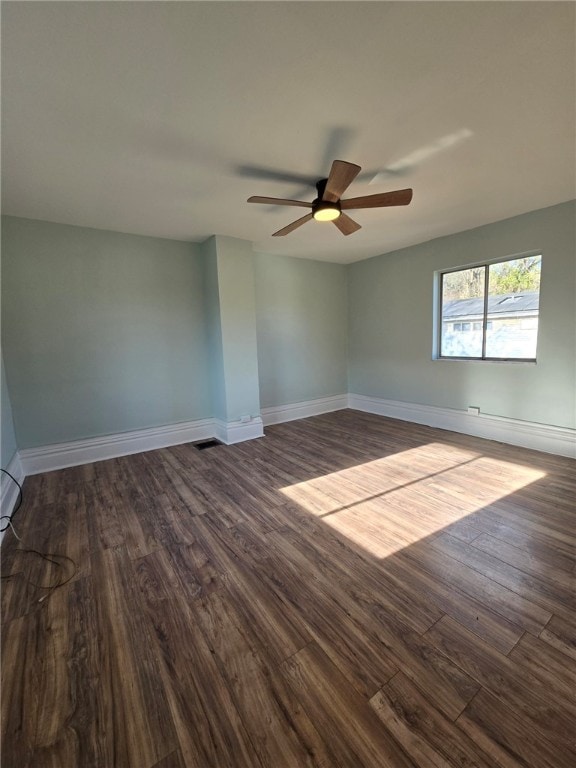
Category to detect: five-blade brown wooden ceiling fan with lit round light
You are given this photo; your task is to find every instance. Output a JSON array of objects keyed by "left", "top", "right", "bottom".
[{"left": 248, "top": 160, "right": 412, "bottom": 237}]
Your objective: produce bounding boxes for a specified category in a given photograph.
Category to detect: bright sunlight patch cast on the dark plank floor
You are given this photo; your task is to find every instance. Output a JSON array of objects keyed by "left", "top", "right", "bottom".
[{"left": 280, "top": 443, "right": 546, "bottom": 558}]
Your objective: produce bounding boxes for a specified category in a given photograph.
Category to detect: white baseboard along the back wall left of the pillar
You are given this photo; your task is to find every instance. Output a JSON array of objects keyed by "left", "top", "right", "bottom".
[{"left": 20, "top": 419, "right": 215, "bottom": 475}]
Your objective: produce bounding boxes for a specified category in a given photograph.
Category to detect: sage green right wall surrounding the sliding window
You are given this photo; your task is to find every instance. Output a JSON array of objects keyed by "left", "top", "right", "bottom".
[{"left": 348, "top": 201, "right": 576, "bottom": 428}]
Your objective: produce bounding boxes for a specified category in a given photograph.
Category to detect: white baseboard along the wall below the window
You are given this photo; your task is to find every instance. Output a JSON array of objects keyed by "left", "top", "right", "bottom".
[{"left": 348, "top": 394, "right": 576, "bottom": 458}]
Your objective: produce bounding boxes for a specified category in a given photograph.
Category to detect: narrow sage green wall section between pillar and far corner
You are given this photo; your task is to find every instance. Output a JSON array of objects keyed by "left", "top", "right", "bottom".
[{"left": 255, "top": 254, "right": 348, "bottom": 408}]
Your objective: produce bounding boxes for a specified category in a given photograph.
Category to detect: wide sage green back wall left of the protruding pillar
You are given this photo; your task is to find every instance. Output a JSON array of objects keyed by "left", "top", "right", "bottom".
[{"left": 2, "top": 217, "right": 211, "bottom": 449}]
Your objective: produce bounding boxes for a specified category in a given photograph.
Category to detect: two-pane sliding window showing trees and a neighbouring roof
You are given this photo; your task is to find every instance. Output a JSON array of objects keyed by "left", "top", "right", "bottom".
[{"left": 437, "top": 254, "right": 542, "bottom": 361}]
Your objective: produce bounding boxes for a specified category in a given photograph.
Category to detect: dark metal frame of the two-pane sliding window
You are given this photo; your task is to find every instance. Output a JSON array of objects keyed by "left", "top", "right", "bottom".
[{"left": 432, "top": 250, "right": 544, "bottom": 365}]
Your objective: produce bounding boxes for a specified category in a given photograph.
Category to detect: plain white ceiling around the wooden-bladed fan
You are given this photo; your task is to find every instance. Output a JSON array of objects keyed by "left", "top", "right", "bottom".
[{"left": 2, "top": 2, "right": 576, "bottom": 263}]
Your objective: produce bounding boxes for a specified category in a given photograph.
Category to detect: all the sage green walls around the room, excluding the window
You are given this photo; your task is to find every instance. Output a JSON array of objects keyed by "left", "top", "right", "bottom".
[{"left": 2, "top": 202, "right": 576, "bottom": 450}]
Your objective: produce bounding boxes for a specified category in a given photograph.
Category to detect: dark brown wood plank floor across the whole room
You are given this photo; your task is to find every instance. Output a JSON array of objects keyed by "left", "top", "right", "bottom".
[{"left": 1, "top": 411, "right": 576, "bottom": 768}]
